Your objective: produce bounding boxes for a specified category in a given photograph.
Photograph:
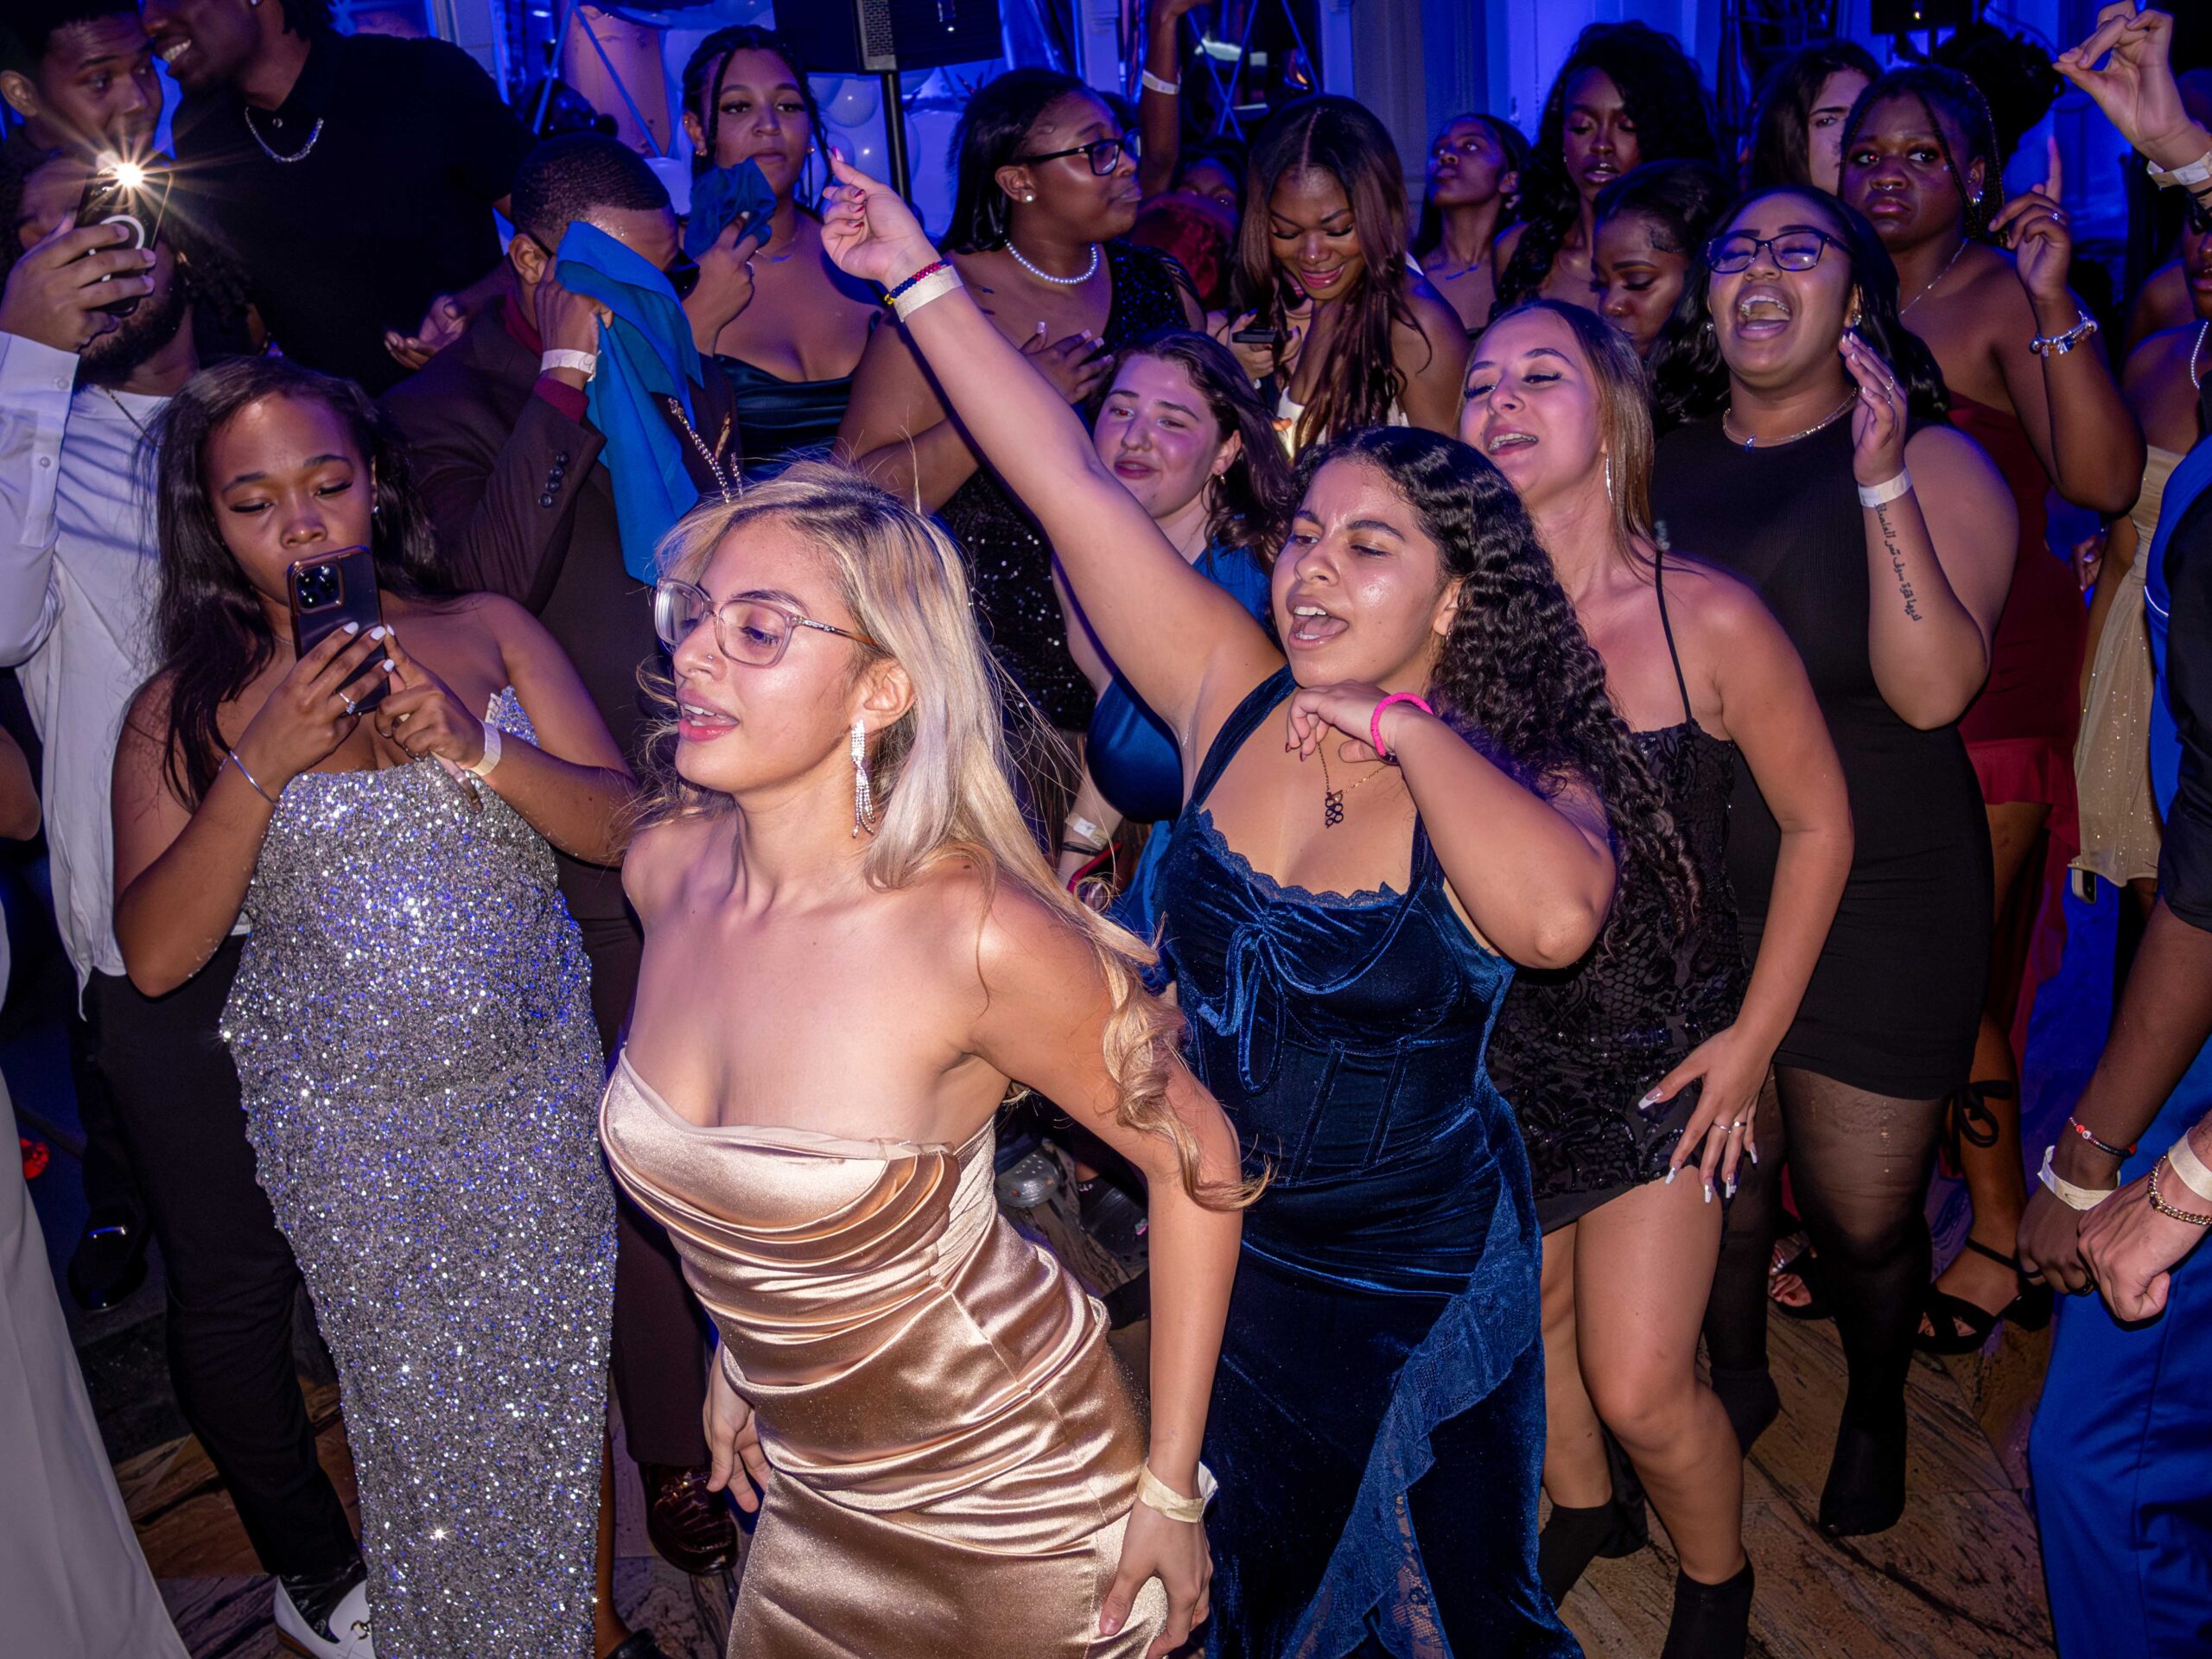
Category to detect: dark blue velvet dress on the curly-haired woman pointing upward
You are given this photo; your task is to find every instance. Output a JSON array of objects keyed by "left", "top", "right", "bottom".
[{"left": 1159, "top": 668, "right": 1577, "bottom": 1659}]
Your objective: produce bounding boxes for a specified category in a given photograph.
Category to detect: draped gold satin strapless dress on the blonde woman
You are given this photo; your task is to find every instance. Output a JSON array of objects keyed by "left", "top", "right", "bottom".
[{"left": 600, "top": 1055, "right": 1166, "bottom": 1659}]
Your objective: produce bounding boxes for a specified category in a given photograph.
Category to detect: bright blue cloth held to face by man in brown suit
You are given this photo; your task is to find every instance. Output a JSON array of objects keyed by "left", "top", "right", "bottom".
[{"left": 553, "top": 219, "right": 702, "bottom": 582}]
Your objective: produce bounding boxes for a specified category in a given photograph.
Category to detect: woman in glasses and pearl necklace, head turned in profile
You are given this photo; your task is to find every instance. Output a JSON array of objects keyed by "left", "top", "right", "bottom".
[{"left": 838, "top": 68, "right": 1204, "bottom": 732}]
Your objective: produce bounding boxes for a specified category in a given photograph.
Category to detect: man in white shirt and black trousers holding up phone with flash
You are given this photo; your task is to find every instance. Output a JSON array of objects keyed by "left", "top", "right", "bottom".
[{"left": 0, "top": 153, "right": 370, "bottom": 1659}]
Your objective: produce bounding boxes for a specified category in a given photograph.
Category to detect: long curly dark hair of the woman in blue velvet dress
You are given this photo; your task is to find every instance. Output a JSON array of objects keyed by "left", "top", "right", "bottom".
[{"left": 1299, "top": 427, "right": 1697, "bottom": 920}]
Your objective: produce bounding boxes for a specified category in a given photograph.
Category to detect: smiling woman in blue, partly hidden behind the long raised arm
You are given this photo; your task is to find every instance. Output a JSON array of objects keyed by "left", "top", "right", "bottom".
[{"left": 1059, "top": 329, "right": 1296, "bottom": 940}]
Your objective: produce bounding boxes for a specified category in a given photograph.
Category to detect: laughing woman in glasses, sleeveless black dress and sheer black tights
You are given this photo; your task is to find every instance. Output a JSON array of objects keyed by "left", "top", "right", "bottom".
[{"left": 1652, "top": 188, "right": 2015, "bottom": 1535}]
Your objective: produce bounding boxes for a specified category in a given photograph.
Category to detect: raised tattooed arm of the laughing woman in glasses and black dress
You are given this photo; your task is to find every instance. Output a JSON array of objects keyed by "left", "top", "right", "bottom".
[{"left": 1842, "top": 334, "right": 2019, "bottom": 730}]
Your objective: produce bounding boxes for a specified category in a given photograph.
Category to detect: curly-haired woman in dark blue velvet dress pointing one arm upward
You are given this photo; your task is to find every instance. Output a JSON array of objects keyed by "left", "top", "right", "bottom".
[{"left": 823, "top": 152, "right": 1681, "bottom": 1659}]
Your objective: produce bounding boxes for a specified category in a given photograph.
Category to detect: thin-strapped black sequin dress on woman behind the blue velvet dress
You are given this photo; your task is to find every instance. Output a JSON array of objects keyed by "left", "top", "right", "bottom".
[{"left": 1491, "top": 553, "right": 1750, "bottom": 1232}]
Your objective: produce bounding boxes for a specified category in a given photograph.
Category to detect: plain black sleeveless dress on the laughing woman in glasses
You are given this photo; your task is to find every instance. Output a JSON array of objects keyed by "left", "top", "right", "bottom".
[{"left": 1652, "top": 420, "right": 1993, "bottom": 1099}]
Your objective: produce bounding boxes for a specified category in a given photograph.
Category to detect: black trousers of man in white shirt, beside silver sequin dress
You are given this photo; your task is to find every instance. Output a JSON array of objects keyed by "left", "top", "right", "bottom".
[{"left": 84, "top": 938, "right": 359, "bottom": 1577}]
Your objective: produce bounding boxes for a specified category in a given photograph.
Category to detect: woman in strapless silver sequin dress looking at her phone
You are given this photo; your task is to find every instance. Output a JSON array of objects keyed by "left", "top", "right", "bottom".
[{"left": 115, "top": 360, "right": 631, "bottom": 1659}]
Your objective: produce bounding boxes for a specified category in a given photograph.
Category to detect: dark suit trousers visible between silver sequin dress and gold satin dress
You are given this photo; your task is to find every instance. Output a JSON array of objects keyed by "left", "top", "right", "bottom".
[{"left": 580, "top": 916, "right": 708, "bottom": 1469}]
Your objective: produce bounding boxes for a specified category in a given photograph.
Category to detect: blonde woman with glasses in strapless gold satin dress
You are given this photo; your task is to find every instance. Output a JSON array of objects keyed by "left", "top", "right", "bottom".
[{"left": 600, "top": 465, "right": 1245, "bottom": 1659}]
